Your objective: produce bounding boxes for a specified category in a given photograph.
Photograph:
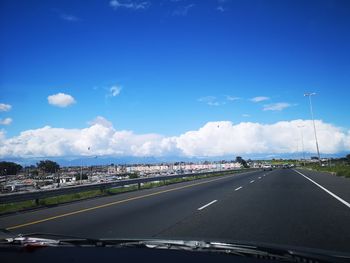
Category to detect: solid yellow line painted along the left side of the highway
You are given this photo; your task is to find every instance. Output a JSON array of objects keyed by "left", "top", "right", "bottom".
[{"left": 6, "top": 174, "right": 246, "bottom": 230}]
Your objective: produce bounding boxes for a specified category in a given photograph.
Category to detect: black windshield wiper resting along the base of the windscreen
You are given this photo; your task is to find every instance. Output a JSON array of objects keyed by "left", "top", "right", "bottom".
[{"left": 0, "top": 233, "right": 350, "bottom": 263}]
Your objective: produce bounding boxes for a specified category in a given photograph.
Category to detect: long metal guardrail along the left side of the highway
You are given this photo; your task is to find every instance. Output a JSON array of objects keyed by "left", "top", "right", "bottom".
[{"left": 0, "top": 169, "right": 251, "bottom": 204}]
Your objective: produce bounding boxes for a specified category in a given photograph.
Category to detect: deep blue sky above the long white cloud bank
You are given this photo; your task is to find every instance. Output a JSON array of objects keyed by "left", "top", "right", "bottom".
[{"left": 0, "top": 0, "right": 350, "bottom": 159}]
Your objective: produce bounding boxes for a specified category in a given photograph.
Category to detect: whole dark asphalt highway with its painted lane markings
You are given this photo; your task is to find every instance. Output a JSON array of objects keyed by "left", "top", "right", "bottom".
[{"left": 0, "top": 169, "right": 350, "bottom": 252}]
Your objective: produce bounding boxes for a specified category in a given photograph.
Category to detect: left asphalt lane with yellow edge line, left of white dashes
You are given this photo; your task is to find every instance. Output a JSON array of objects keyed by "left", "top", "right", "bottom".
[{"left": 0, "top": 171, "right": 261, "bottom": 237}]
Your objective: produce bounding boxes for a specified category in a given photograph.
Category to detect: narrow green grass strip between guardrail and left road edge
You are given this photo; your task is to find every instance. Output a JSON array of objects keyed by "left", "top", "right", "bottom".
[{"left": 0, "top": 169, "right": 253, "bottom": 214}]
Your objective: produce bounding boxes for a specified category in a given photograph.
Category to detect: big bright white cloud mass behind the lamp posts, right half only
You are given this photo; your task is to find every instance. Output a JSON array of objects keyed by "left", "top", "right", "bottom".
[{"left": 177, "top": 120, "right": 350, "bottom": 156}]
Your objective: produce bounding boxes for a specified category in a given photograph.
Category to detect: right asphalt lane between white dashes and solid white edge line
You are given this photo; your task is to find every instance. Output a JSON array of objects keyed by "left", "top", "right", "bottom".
[{"left": 157, "top": 169, "right": 350, "bottom": 252}]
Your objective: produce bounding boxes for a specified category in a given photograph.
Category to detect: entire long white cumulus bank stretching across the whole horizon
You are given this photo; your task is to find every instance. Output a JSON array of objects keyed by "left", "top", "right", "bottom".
[{"left": 0, "top": 119, "right": 350, "bottom": 158}]
